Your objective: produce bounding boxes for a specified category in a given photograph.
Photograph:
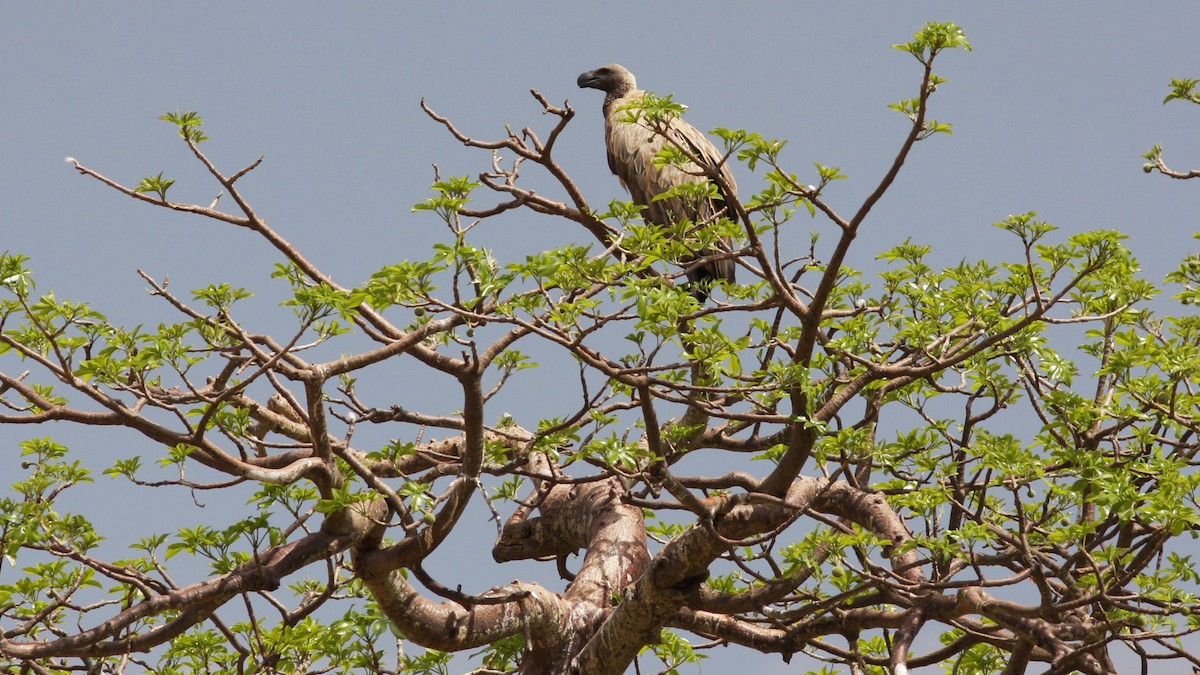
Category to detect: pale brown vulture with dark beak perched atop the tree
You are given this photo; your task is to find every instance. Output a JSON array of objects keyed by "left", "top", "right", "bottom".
[{"left": 576, "top": 64, "right": 738, "bottom": 303}]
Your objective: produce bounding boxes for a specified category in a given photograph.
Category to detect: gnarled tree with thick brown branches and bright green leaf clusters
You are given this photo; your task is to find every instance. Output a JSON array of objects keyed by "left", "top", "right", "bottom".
[{"left": 0, "top": 24, "right": 1200, "bottom": 674}]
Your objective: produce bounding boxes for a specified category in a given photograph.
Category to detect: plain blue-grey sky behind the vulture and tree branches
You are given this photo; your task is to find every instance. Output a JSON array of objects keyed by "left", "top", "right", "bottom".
[{"left": 0, "top": 1, "right": 1200, "bottom": 673}]
